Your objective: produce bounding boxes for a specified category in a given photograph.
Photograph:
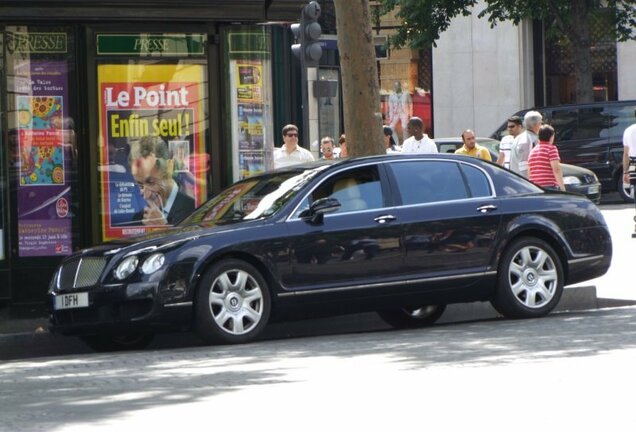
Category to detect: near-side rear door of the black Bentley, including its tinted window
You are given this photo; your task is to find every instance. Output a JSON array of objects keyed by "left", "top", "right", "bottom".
[{"left": 390, "top": 159, "right": 501, "bottom": 289}]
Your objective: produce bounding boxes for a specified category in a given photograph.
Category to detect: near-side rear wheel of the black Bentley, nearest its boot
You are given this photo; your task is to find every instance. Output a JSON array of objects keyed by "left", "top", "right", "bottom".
[{"left": 491, "top": 237, "right": 564, "bottom": 318}]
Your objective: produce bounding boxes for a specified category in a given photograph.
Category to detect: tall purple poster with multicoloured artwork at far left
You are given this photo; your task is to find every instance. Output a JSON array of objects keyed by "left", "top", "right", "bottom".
[{"left": 15, "top": 61, "right": 74, "bottom": 257}]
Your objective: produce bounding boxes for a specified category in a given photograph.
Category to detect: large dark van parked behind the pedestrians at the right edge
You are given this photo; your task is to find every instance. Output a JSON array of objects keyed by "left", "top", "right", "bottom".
[{"left": 491, "top": 100, "right": 636, "bottom": 201}]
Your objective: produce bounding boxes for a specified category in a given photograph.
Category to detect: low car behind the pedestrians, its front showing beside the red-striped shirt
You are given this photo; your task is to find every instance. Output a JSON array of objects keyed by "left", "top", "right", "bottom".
[{"left": 435, "top": 137, "right": 602, "bottom": 204}]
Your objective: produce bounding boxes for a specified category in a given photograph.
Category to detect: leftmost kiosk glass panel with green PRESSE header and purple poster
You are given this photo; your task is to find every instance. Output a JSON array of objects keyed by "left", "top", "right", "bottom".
[{"left": 3, "top": 26, "right": 78, "bottom": 257}]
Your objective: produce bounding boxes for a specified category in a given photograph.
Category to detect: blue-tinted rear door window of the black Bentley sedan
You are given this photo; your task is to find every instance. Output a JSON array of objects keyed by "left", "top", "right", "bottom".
[{"left": 391, "top": 161, "right": 469, "bottom": 205}]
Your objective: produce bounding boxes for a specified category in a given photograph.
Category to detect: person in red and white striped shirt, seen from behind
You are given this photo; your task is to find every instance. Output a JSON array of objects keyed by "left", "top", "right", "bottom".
[{"left": 528, "top": 125, "right": 565, "bottom": 191}]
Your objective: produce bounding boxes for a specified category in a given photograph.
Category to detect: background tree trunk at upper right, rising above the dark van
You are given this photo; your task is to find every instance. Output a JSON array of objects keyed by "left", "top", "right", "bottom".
[{"left": 567, "top": 0, "right": 594, "bottom": 103}]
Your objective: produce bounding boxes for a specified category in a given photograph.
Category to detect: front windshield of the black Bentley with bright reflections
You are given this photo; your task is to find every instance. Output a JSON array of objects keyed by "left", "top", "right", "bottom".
[{"left": 179, "top": 165, "right": 327, "bottom": 226}]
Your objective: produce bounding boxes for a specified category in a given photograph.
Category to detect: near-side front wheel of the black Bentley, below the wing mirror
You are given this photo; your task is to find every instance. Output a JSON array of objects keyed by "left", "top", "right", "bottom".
[{"left": 195, "top": 259, "right": 271, "bottom": 344}]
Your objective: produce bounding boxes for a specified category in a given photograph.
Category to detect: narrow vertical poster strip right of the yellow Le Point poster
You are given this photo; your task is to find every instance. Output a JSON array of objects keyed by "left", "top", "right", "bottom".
[{"left": 234, "top": 60, "right": 266, "bottom": 179}]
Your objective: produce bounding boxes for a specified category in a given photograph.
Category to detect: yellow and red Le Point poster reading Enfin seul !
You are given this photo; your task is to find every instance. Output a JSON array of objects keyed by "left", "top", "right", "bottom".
[{"left": 98, "top": 64, "right": 209, "bottom": 240}]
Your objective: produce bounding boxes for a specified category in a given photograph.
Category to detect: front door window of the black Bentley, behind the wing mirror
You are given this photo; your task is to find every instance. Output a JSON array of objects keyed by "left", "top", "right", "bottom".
[{"left": 296, "top": 166, "right": 384, "bottom": 216}]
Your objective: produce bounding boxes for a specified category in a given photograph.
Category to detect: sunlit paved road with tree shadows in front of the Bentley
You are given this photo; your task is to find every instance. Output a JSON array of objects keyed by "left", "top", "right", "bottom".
[{"left": 0, "top": 307, "right": 636, "bottom": 432}]
